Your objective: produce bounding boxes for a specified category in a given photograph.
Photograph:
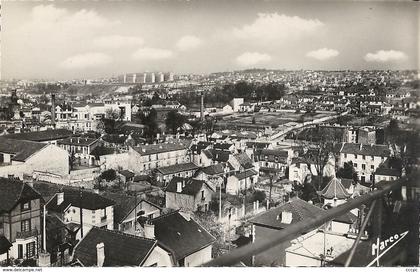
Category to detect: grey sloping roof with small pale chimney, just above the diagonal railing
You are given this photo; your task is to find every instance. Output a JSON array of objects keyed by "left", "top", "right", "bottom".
[{"left": 250, "top": 198, "right": 325, "bottom": 229}]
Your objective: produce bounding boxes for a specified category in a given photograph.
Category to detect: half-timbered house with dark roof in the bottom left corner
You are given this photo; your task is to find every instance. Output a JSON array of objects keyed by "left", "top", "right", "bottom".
[{"left": 0, "top": 178, "right": 42, "bottom": 262}]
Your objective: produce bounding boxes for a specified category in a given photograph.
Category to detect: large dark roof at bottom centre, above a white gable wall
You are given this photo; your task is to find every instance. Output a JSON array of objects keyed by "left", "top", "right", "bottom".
[{"left": 150, "top": 211, "right": 216, "bottom": 260}]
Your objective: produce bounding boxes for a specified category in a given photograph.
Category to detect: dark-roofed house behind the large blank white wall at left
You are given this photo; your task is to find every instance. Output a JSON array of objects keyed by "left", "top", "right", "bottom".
[{"left": 57, "top": 137, "right": 99, "bottom": 166}]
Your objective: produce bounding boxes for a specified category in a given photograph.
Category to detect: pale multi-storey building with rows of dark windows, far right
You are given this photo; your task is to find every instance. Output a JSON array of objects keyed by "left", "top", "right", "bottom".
[{"left": 339, "top": 143, "right": 391, "bottom": 183}]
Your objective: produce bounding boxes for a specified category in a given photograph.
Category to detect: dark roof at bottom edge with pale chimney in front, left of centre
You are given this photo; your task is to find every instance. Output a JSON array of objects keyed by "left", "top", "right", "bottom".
[{"left": 74, "top": 227, "right": 157, "bottom": 266}]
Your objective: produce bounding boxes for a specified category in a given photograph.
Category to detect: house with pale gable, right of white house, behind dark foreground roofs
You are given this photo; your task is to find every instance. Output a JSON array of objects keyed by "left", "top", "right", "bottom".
[{"left": 102, "top": 192, "right": 162, "bottom": 234}]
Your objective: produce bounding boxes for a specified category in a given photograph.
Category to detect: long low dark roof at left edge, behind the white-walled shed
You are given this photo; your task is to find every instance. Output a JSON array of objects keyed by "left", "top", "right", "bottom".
[{"left": 3, "top": 129, "right": 73, "bottom": 142}]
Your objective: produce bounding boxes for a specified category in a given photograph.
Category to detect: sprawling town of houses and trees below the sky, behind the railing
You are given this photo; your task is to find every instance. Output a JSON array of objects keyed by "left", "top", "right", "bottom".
[{"left": 0, "top": 70, "right": 420, "bottom": 267}]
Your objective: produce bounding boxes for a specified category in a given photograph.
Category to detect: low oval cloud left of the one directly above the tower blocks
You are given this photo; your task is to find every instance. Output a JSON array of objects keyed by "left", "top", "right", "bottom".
[{"left": 60, "top": 53, "right": 112, "bottom": 69}]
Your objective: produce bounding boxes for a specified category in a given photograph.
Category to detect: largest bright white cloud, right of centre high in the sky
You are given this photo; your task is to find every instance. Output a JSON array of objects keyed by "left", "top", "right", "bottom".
[{"left": 233, "top": 13, "right": 324, "bottom": 42}]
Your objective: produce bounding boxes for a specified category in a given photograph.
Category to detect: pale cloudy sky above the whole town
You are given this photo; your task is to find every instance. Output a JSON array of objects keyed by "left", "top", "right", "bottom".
[{"left": 1, "top": 0, "right": 420, "bottom": 80}]
